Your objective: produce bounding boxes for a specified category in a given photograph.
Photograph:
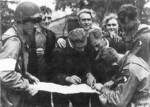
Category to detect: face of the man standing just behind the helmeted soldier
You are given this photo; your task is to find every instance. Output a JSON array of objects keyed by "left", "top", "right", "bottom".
[{"left": 42, "top": 13, "right": 52, "bottom": 27}]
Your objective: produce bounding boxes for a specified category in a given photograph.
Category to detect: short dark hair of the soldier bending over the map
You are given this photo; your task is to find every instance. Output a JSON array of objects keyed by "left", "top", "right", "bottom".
[{"left": 96, "top": 47, "right": 118, "bottom": 66}]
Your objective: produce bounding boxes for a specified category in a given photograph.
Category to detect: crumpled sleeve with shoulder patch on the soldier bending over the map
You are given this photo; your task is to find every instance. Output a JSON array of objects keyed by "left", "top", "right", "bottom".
[{"left": 101, "top": 70, "right": 138, "bottom": 107}]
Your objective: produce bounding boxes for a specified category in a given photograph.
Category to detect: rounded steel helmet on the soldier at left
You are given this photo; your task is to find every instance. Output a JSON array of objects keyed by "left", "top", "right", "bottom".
[{"left": 15, "top": 1, "right": 42, "bottom": 21}]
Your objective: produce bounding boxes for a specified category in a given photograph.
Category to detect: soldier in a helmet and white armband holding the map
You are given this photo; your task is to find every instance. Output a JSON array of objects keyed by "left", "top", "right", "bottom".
[{"left": 0, "top": 2, "right": 41, "bottom": 107}]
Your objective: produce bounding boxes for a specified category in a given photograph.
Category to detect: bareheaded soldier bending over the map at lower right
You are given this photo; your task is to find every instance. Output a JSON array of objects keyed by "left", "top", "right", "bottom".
[{"left": 95, "top": 48, "right": 150, "bottom": 107}]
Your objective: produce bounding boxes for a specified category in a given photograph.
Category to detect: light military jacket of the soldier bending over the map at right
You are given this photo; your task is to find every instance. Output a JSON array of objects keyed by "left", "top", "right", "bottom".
[{"left": 101, "top": 54, "right": 150, "bottom": 107}]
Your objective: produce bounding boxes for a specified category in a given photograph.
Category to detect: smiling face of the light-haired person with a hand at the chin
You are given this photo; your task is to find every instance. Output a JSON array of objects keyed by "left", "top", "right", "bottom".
[{"left": 106, "top": 18, "right": 119, "bottom": 33}]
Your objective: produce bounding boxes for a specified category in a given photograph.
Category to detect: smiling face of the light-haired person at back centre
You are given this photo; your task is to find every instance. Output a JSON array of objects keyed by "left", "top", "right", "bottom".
[{"left": 79, "top": 13, "right": 92, "bottom": 30}]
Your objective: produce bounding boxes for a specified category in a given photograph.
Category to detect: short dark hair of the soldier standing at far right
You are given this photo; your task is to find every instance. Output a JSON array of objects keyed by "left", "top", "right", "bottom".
[{"left": 118, "top": 4, "right": 138, "bottom": 21}]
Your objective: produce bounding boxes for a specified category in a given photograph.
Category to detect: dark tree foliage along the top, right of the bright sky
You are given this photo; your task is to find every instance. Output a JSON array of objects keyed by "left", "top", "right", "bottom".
[{"left": 56, "top": 0, "right": 148, "bottom": 22}]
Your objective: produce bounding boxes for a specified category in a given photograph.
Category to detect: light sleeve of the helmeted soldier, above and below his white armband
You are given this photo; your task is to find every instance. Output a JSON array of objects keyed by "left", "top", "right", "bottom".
[{"left": 0, "top": 37, "right": 29, "bottom": 91}]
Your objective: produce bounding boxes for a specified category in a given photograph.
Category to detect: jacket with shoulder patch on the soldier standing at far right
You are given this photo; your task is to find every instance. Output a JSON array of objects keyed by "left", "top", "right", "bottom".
[{"left": 126, "top": 24, "right": 150, "bottom": 65}]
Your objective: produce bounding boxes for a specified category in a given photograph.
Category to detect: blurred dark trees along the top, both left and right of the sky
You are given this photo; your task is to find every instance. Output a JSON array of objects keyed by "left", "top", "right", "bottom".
[{"left": 0, "top": 0, "right": 150, "bottom": 35}]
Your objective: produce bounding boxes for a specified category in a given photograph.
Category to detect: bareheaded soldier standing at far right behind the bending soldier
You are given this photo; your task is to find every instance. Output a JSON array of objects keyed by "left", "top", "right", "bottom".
[{"left": 118, "top": 4, "right": 150, "bottom": 65}]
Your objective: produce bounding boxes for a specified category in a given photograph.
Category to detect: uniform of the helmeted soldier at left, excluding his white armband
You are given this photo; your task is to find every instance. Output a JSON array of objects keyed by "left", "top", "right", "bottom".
[{"left": 0, "top": 26, "right": 29, "bottom": 106}]
